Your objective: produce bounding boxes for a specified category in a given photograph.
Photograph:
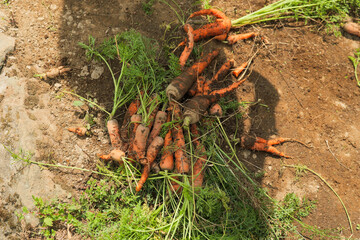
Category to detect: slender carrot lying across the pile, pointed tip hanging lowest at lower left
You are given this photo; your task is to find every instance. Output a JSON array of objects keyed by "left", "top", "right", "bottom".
[{"left": 136, "top": 137, "right": 164, "bottom": 192}]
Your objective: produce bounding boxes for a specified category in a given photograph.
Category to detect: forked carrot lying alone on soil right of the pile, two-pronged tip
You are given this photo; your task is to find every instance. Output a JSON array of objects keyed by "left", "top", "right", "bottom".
[{"left": 241, "top": 136, "right": 291, "bottom": 158}]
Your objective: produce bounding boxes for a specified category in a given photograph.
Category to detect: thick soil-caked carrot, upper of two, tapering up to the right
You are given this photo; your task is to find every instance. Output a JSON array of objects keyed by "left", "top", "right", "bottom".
[{"left": 166, "top": 50, "right": 219, "bottom": 100}]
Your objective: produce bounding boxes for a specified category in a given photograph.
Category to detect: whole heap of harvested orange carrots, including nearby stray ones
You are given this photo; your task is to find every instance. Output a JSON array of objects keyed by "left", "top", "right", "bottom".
[{"left": 69, "top": 9, "right": 288, "bottom": 192}]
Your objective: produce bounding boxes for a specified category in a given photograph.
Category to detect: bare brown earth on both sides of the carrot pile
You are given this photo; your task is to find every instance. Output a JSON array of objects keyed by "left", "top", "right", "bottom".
[{"left": 0, "top": 0, "right": 360, "bottom": 238}]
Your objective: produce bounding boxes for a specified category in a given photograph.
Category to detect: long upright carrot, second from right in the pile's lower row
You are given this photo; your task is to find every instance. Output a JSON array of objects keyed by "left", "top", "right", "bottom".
[{"left": 172, "top": 104, "right": 191, "bottom": 174}]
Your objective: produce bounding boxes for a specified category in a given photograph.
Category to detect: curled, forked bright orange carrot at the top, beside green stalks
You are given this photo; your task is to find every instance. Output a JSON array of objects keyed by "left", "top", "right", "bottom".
[{"left": 179, "top": 9, "right": 231, "bottom": 46}]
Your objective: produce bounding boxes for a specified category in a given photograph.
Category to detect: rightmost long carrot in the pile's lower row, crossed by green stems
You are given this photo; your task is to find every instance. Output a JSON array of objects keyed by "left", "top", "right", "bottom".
[{"left": 190, "top": 124, "right": 207, "bottom": 188}]
